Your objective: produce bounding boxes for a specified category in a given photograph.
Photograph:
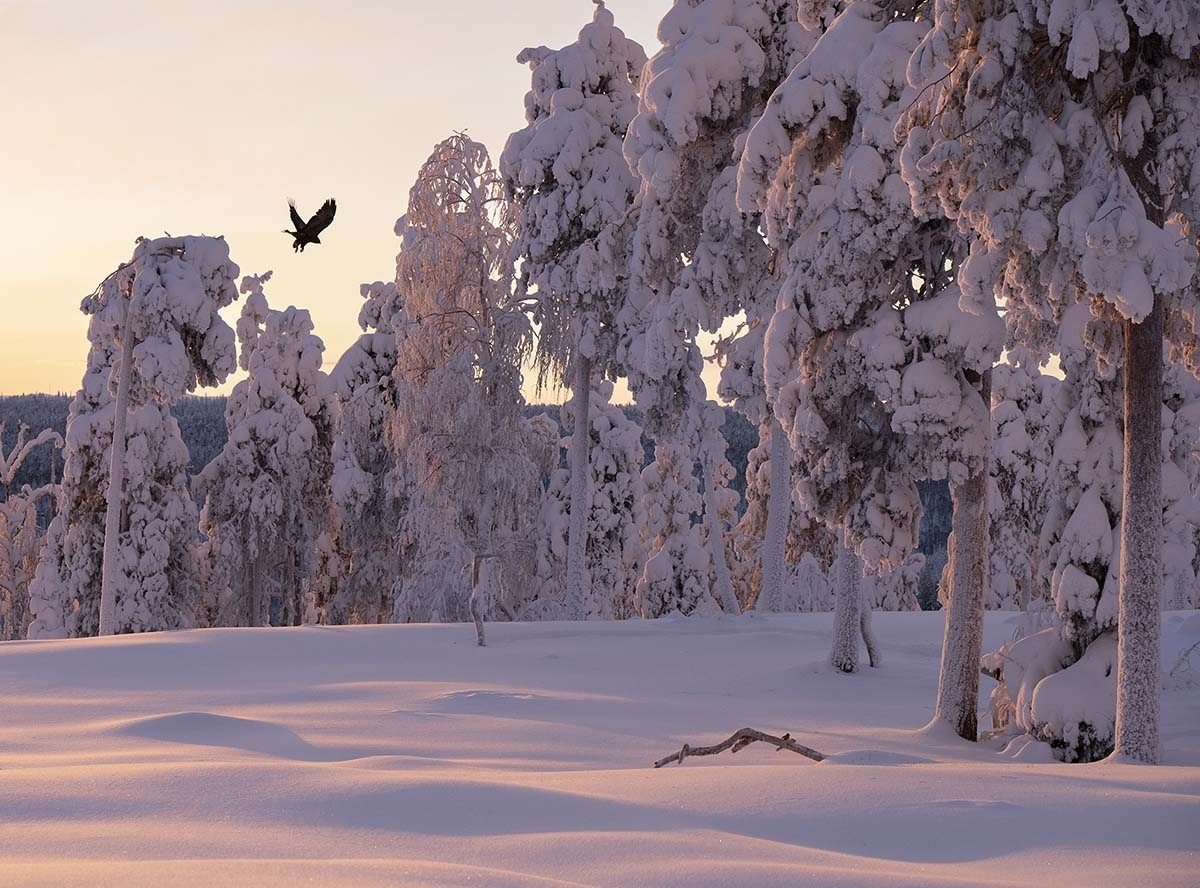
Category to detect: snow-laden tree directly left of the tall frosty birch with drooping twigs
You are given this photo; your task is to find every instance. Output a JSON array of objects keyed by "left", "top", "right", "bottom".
[{"left": 328, "top": 281, "right": 404, "bottom": 624}]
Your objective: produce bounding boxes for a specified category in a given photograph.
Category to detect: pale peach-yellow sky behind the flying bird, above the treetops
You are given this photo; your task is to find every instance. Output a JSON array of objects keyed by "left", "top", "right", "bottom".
[{"left": 0, "top": 0, "right": 670, "bottom": 394}]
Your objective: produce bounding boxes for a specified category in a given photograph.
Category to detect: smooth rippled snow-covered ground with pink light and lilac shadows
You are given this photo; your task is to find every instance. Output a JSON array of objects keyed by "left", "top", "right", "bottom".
[{"left": 0, "top": 613, "right": 1200, "bottom": 888}]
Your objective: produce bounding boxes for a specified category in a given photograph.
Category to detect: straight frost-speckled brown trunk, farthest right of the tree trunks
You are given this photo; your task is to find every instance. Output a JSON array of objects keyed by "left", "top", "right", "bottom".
[{"left": 1112, "top": 298, "right": 1163, "bottom": 764}]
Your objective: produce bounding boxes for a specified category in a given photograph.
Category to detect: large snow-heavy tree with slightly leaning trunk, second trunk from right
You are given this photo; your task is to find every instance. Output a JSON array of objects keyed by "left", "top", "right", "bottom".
[{"left": 738, "top": 2, "right": 1003, "bottom": 700}]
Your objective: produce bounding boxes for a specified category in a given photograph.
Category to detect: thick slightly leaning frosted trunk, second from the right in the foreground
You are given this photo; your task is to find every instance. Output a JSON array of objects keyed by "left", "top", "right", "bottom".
[{"left": 934, "top": 370, "right": 991, "bottom": 740}]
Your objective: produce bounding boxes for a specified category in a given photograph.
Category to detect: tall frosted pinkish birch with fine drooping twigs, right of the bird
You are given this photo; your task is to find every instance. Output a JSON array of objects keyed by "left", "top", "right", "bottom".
[{"left": 389, "top": 134, "right": 542, "bottom": 644}]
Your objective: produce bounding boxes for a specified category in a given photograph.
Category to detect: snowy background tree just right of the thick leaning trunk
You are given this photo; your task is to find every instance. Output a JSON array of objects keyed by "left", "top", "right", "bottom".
[{"left": 985, "top": 349, "right": 1058, "bottom": 611}]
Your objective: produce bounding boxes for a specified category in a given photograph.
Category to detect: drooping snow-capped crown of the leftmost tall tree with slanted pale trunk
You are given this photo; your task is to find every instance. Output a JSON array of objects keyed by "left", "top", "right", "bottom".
[{"left": 80, "top": 236, "right": 238, "bottom": 404}]
